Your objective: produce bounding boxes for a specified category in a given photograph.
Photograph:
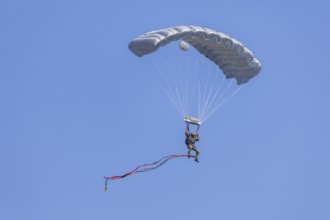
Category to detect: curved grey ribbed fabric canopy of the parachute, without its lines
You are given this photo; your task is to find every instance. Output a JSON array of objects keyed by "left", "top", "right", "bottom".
[{"left": 129, "top": 26, "right": 261, "bottom": 84}]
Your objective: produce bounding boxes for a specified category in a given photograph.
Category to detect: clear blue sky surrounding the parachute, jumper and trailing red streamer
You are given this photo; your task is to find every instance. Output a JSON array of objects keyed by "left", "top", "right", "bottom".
[{"left": 0, "top": 0, "right": 330, "bottom": 220}]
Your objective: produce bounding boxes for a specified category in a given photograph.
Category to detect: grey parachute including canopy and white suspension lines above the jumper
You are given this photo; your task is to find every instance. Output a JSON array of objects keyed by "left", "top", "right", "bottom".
[{"left": 128, "top": 26, "right": 261, "bottom": 124}]
